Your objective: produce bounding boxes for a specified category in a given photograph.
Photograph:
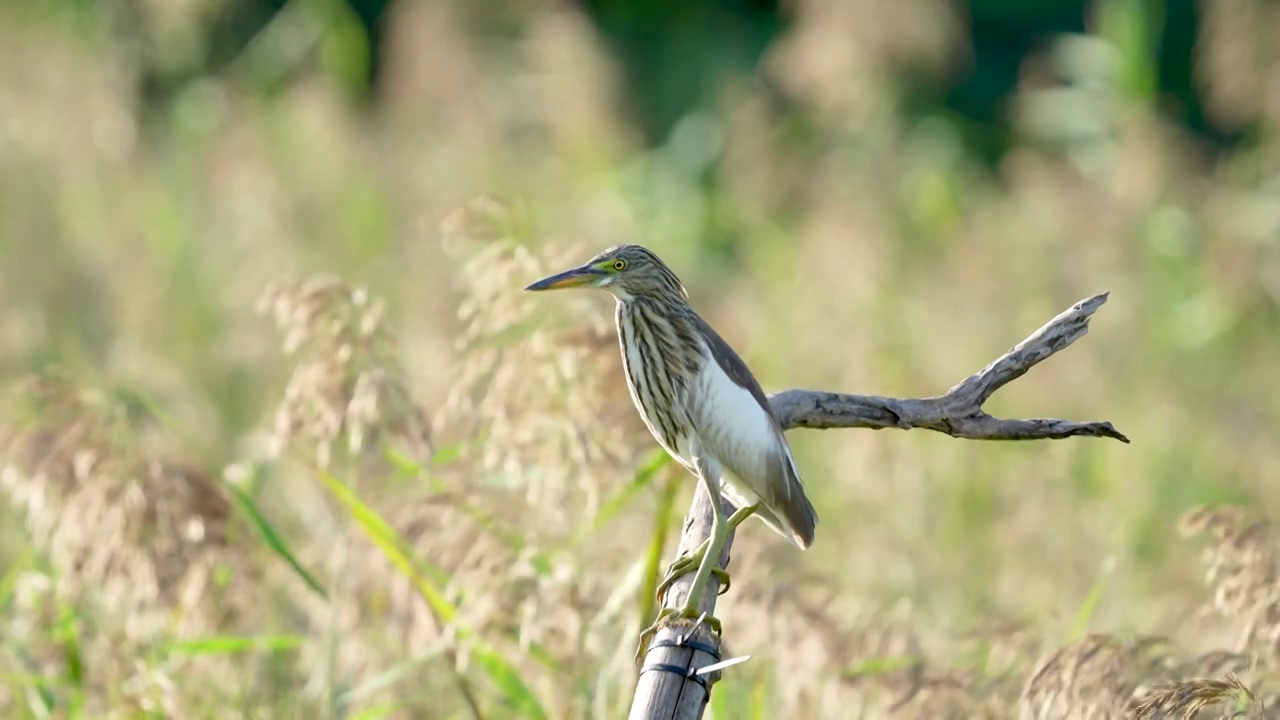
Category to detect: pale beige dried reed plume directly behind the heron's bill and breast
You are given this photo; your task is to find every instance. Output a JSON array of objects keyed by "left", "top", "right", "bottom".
[{"left": 440, "top": 196, "right": 652, "bottom": 530}]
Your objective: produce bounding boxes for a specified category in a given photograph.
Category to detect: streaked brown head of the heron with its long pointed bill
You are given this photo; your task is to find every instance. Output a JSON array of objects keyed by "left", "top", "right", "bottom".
[{"left": 525, "top": 245, "right": 687, "bottom": 301}]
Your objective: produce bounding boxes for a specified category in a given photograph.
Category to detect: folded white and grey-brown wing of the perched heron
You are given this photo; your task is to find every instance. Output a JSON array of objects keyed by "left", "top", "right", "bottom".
[{"left": 692, "top": 312, "right": 818, "bottom": 548}]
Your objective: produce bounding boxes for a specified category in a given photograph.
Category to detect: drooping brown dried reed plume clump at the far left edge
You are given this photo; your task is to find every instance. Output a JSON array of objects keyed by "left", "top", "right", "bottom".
[{"left": 0, "top": 370, "right": 239, "bottom": 712}]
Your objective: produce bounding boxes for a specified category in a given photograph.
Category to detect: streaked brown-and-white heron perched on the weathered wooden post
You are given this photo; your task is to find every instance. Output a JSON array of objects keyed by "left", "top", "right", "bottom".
[{"left": 525, "top": 245, "right": 818, "bottom": 652}]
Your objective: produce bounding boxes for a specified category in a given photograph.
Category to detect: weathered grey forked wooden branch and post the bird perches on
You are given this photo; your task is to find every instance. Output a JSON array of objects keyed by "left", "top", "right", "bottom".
[{"left": 630, "top": 293, "right": 1129, "bottom": 720}]
